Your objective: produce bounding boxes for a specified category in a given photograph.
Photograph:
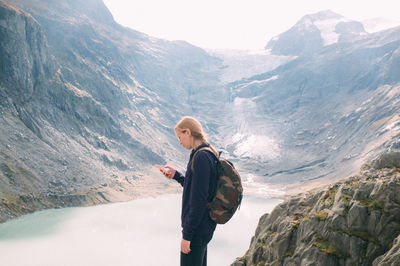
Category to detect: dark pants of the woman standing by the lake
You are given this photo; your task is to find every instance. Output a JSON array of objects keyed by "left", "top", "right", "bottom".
[{"left": 181, "top": 234, "right": 213, "bottom": 266}]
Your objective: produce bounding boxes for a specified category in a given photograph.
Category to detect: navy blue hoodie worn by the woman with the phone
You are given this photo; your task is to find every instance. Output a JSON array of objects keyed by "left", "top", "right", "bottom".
[{"left": 174, "top": 143, "right": 216, "bottom": 241}]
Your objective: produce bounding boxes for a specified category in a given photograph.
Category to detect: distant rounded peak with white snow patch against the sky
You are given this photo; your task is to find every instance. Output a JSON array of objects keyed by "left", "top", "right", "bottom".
[{"left": 265, "top": 10, "right": 367, "bottom": 55}]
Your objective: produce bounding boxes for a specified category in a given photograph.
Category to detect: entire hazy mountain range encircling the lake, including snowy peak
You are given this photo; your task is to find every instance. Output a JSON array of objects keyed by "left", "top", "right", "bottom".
[{"left": 0, "top": 0, "right": 400, "bottom": 233}]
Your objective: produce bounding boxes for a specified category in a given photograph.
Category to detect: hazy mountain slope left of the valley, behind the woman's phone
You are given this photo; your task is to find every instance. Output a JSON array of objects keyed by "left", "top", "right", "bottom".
[{"left": 0, "top": 0, "right": 221, "bottom": 221}]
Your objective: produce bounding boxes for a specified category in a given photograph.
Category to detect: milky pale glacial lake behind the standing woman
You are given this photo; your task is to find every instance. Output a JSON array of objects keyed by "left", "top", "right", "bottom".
[{"left": 0, "top": 194, "right": 280, "bottom": 266}]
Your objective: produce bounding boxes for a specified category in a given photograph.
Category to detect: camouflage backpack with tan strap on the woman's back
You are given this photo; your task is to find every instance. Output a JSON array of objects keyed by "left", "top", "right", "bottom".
[{"left": 191, "top": 147, "right": 243, "bottom": 224}]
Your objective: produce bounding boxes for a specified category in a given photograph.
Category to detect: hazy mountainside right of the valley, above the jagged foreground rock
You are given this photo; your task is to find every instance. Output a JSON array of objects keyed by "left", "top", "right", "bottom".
[{"left": 218, "top": 22, "right": 400, "bottom": 191}]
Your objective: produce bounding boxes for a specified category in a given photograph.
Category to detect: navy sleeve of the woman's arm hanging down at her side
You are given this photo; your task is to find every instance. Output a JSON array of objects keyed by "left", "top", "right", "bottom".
[{"left": 182, "top": 151, "right": 212, "bottom": 241}]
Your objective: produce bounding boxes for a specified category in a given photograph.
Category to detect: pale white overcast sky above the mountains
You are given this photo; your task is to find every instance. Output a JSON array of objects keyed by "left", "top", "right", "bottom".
[{"left": 103, "top": 0, "right": 400, "bottom": 50}]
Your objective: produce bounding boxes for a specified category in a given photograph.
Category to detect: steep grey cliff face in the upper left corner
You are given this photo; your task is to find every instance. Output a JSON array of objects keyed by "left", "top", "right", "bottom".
[{"left": 0, "top": 2, "right": 54, "bottom": 102}]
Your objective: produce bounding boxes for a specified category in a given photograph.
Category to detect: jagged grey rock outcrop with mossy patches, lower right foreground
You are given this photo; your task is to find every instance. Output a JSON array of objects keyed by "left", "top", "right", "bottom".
[{"left": 232, "top": 151, "right": 400, "bottom": 266}]
